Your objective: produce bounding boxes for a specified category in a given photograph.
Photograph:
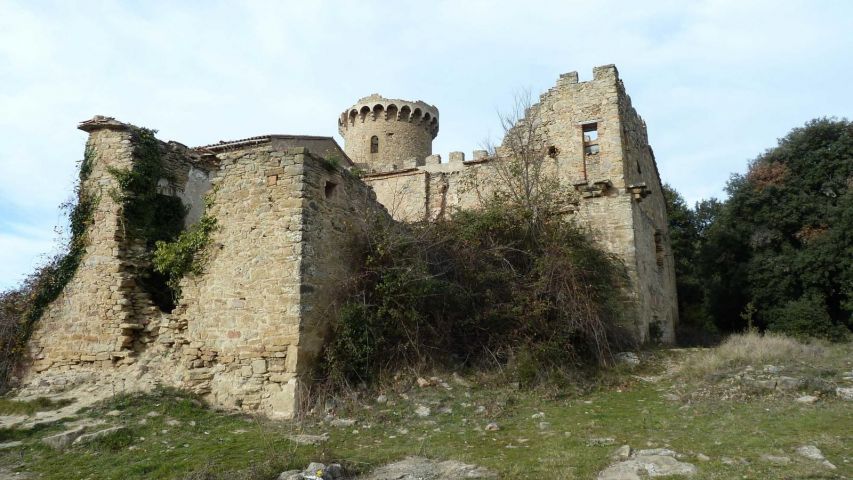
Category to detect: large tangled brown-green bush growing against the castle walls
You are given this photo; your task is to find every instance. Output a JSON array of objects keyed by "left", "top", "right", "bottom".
[{"left": 321, "top": 202, "right": 626, "bottom": 385}]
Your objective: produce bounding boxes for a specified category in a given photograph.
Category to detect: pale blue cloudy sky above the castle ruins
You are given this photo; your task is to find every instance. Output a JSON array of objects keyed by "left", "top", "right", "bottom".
[{"left": 0, "top": 0, "right": 853, "bottom": 290}]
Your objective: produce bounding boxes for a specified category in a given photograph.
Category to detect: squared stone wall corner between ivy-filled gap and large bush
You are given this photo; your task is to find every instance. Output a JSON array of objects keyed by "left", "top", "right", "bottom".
[{"left": 159, "top": 145, "right": 381, "bottom": 417}]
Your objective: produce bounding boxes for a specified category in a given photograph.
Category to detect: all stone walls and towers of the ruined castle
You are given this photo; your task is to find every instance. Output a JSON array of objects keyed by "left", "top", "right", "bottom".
[{"left": 16, "top": 66, "right": 677, "bottom": 417}]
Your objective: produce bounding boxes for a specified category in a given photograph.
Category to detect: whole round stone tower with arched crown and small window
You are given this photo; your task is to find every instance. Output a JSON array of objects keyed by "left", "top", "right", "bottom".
[{"left": 338, "top": 94, "right": 438, "bottom": 172}]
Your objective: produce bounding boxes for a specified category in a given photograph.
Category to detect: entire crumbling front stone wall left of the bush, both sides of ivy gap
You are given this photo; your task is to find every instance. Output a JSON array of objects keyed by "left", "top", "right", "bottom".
[{"left": 24, "top": 122, "right": 387, "bottom": 417}]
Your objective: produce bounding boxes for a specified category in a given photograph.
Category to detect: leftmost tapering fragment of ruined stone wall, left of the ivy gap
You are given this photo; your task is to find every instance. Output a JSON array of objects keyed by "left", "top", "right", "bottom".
[{"left": 28, "top": 127, "right": 138, "bottom": 373}]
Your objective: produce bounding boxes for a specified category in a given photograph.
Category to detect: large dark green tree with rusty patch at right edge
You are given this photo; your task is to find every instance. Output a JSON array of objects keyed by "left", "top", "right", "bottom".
[{"left": 699, "top": 118, "right": 853, "bottom": 338}]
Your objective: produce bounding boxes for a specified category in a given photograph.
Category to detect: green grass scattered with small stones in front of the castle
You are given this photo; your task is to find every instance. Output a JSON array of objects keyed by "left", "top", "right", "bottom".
[{"left": 0, "top": 345, "right": 853, "bottom": 480}]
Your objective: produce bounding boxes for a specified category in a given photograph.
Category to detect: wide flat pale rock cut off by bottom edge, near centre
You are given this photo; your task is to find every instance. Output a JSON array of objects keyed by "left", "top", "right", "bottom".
[{"left": 363, "top": 457, "right": 497, "bottom": 480}]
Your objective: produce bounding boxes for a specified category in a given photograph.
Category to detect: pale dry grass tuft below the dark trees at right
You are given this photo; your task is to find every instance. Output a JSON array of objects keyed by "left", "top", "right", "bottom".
[{"left": 683, "top": 332, "right": 827, "bottom": 375}]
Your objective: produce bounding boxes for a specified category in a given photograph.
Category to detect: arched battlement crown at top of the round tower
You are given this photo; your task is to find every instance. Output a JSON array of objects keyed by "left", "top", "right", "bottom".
[{"left": 338, "top": 93, "right": 438, "bottom": 138}]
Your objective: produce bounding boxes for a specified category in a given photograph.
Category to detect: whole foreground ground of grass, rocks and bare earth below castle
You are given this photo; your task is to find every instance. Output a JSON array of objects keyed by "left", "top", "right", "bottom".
[{"left": 0, "top": 336, "right": 853, "bottom": 480}]
